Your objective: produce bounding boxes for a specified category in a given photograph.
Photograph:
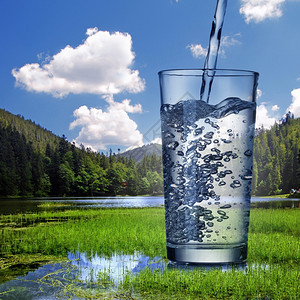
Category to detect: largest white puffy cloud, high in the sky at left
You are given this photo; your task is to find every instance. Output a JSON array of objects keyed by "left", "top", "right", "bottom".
[{"left": 12, "top": 27, "right": 145, "bottom": 98}]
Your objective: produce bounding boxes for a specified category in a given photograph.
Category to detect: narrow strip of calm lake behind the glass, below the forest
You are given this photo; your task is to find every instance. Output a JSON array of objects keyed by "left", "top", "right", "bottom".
[{"left": 0, "top": 196, "right": 300, "bottom": 214}]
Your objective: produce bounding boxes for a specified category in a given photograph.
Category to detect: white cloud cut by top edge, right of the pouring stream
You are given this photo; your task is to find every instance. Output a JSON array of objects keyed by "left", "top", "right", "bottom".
[{"left": 240, "top": 0, "right": 286, "bottom": 23}]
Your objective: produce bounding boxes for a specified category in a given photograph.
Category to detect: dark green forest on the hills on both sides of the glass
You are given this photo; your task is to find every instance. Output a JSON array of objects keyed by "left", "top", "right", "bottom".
[{"left": 0, "top": 109, "right": 300, "bottom": 197}]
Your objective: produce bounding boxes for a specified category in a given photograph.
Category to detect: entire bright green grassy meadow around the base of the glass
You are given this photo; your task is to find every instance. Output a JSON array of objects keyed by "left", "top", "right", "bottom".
[{"left": 0, "top": 207, "right": 300, "bottom": 299}]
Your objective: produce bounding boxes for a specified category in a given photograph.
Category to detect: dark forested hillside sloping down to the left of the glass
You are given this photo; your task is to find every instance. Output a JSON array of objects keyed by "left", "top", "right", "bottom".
[{"left": 0, "top": 110, "right": 163, "bottom": 196}]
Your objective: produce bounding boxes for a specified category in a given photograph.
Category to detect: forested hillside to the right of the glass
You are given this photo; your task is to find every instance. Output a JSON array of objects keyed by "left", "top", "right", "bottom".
[{"left": 252, "top": 118, "right": 300, "bottom": 195}]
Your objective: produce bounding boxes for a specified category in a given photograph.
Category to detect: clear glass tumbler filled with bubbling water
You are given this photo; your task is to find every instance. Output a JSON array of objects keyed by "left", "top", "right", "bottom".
[{"left": 159, "top": 69, "right": 258, "bottom": 264}]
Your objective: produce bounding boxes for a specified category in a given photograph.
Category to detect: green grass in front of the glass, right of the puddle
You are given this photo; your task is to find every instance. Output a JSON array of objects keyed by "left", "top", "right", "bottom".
[{"left": 122, "top": 265, "right": 300, "bottom": 299}]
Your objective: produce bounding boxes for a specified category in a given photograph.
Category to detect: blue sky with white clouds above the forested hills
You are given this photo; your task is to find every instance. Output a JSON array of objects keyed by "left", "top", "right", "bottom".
[{"left": 0, "top": 0, "right": 300, "bottom": 152}]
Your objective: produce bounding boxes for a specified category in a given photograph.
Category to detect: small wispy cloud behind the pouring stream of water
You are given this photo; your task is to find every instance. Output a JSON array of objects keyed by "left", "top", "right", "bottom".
[{"left": 186, "top": 33, "right": 241, "bottom": 58}]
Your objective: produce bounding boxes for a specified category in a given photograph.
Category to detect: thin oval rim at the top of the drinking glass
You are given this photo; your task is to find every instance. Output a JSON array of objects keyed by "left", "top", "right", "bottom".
[{"left": 158, "top": 68, "right": 259, "bottom": 77}]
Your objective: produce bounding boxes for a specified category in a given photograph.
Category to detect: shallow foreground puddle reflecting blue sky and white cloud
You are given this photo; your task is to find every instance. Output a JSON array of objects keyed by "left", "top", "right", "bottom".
[{"left": 0, "top": 252, "right": 268, "bottom": 300}]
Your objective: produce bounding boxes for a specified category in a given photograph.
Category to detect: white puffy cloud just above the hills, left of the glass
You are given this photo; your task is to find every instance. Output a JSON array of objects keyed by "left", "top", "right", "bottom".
[{"left": 70, "top": 97, "right": 143, "bottom": 150}]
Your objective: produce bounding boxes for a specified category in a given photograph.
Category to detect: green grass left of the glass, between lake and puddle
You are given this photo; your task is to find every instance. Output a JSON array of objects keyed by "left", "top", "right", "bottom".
[{"left": 0, "top": 208, "right": 166, "bottom": 256}]
